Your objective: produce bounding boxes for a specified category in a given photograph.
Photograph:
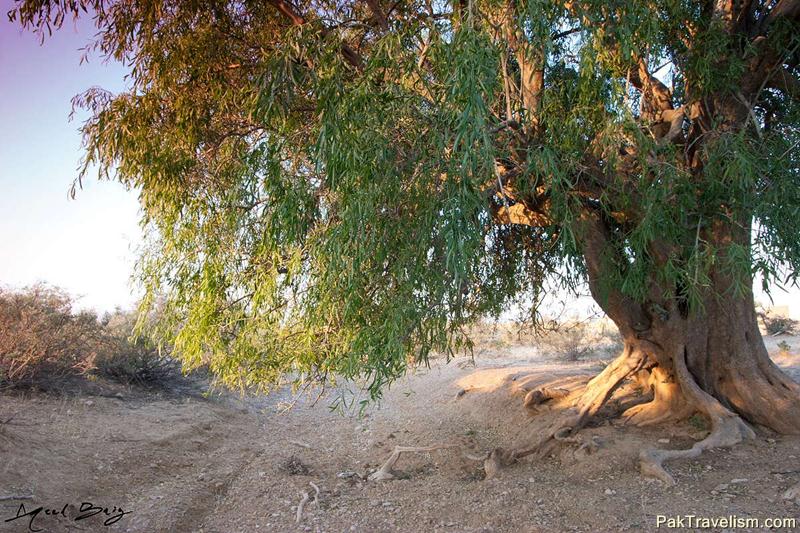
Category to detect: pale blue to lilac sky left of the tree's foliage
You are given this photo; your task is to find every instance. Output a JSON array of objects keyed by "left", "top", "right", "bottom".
[{"left": 0, "top": 0, "right": 141, "bottom": 312}]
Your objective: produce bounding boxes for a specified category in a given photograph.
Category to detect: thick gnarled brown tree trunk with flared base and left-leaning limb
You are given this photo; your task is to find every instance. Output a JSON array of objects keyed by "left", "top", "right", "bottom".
[{"left": 583, "top": 210, "right": 800, "bottom": 434}]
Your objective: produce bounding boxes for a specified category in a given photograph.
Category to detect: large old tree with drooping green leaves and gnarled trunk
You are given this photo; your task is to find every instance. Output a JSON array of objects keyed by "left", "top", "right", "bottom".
[{"left": 10, "top": 0, "right": 800, "bottom": 480}]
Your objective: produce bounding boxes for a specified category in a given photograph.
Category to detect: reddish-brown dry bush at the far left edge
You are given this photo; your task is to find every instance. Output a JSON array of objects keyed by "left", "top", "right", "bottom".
[{"left": 0, "top": 285, "right": 105, "bottom": 383}]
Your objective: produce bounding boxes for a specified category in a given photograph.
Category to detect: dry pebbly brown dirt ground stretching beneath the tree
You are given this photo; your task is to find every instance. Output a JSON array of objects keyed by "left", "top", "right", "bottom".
[{"left": 0, "top": 337, "right": 800, "bottom": 532}]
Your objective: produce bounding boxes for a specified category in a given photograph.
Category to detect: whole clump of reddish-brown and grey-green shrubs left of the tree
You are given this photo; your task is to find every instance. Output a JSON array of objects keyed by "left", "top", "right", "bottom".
[{"left": 0, "top": 285, "right": 180, "bottom": 387}]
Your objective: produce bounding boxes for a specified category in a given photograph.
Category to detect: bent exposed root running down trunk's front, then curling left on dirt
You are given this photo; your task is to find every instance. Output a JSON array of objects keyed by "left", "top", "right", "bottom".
[{"left": 639, "top": 348, "right": 755, "bottom": 485}]
